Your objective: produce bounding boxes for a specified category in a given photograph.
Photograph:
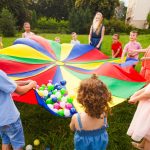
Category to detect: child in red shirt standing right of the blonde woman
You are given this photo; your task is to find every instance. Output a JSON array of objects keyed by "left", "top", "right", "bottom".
[{"left": 111, "top": 34, "right": 122, "bottom": 58}]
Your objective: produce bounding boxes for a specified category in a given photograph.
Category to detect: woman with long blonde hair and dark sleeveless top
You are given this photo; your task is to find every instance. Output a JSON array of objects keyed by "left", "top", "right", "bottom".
[{"left": 89, "top": 12, "right": 105, "bottom": 50}]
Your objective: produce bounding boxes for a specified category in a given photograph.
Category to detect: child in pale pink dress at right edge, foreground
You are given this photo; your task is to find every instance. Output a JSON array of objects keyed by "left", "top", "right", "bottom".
[{"left": 127, "top": 84, "right": 150, "bottom": 150}]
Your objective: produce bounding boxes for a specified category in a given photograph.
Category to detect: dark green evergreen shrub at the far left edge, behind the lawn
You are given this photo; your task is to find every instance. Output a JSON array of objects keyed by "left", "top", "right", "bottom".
[{"left": 0, "top": 9, "right": 16, "bottom": 37}]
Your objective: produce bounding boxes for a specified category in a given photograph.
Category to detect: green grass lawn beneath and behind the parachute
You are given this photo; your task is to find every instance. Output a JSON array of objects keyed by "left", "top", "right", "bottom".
[{"left": 3, "top": 34, "right": 150, "bottom": 150}]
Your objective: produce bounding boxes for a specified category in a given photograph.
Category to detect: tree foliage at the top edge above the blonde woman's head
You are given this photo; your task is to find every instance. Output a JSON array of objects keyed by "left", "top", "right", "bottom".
[{"left": 75, "top": 0, "right": 119, "bottom": 19}]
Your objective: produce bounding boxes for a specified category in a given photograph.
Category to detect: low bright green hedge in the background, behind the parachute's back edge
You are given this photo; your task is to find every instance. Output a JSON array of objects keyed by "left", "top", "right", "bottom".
[{"left": 37, "top": 17, "right": 69, "bottom": 33}]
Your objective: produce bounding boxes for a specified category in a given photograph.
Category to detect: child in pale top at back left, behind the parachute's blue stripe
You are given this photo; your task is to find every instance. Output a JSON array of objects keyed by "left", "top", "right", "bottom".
[{"left": 22, "top": 22, "right": 34, "bottom": 38}]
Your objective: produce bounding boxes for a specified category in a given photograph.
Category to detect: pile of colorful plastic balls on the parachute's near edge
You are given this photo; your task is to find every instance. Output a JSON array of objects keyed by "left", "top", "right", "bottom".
[{"left": 36, "top": 80, "right": 76, "bottom": 117}]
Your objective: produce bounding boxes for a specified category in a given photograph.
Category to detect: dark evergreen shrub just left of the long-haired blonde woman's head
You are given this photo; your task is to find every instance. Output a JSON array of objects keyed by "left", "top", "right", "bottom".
[{"left": 69, "top": 8, "right": 92, "bottom": 34}]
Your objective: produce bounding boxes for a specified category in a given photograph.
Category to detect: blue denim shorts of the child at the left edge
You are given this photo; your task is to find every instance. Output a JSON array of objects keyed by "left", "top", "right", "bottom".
[{"left": 0, "top": 118, "right": 25, "bottom": 150}]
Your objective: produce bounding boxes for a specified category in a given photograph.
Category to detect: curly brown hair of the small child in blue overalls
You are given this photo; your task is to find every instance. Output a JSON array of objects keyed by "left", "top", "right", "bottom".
[{"left": 77, "top": 74, "right": 111, "bottom": 118}]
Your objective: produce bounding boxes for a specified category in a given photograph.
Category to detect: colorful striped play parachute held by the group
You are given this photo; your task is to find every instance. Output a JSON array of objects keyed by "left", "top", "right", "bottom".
[{"left": 0, "top": 36, "right": 145, "bottom": 116}]
